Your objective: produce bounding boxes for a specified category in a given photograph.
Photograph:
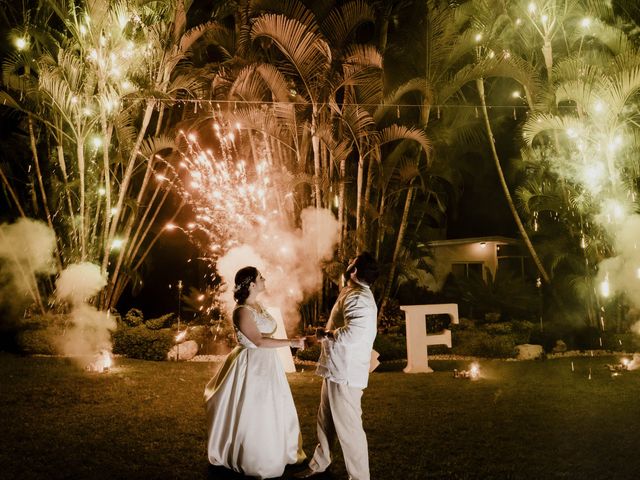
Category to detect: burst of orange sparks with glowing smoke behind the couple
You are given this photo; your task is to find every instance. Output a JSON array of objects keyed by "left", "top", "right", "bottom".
[{"left": 162, "top": 119, "right": 339, "bottom": 334}]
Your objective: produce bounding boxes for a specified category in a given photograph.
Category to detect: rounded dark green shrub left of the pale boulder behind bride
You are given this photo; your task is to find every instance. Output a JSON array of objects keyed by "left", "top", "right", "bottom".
[{"left": 112, "top": 325, "right": 175, "bottom": 360}]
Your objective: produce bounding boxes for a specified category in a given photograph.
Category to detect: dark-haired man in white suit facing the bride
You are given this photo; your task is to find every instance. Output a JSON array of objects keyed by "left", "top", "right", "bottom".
[{"left": 296, "top": 252, "right": 378, "bottom": 480}]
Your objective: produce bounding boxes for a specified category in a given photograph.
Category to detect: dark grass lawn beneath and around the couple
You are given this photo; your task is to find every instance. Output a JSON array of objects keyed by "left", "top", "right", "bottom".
[{"left": 0, "top": 355, "right": 640, "bottom": 480}]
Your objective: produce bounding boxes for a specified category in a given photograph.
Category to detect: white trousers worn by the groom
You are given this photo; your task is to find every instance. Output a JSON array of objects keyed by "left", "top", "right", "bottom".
[{"left": 309, "top": 379, "right": 369, "bottom": 480}]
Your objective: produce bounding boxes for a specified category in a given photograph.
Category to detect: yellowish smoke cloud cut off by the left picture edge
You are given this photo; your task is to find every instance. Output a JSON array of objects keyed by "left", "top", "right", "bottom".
[{"left": 0, "top": 218, "right": 56, "bottom": 311}]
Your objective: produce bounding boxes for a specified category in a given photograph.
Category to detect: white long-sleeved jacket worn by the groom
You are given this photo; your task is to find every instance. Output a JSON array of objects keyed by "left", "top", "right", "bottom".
[{"left": 316, "top": 281, "right": 378, "bottom": 388}]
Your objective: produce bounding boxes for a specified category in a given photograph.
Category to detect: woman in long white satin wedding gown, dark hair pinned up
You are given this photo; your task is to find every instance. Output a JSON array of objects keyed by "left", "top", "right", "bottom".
[{"left": 204, "top": 267, "right": 305, "bottom": 479}]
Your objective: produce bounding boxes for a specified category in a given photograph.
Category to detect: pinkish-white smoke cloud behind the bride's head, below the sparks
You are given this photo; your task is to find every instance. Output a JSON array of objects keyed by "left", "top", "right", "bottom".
[{"left": 217, "top": 207, "right": 340, "bottom": 329}]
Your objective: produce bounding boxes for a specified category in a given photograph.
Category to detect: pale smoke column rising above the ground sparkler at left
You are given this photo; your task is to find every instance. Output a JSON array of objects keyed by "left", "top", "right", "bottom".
[{"left": 56, "top": 262, "right": 116, "bottom": 357}]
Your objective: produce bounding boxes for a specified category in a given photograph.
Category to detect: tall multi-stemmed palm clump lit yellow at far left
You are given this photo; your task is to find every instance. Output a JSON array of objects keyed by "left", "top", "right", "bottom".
[{"left": 2, "top": 1, "right": 220, "bottom": 308}]
